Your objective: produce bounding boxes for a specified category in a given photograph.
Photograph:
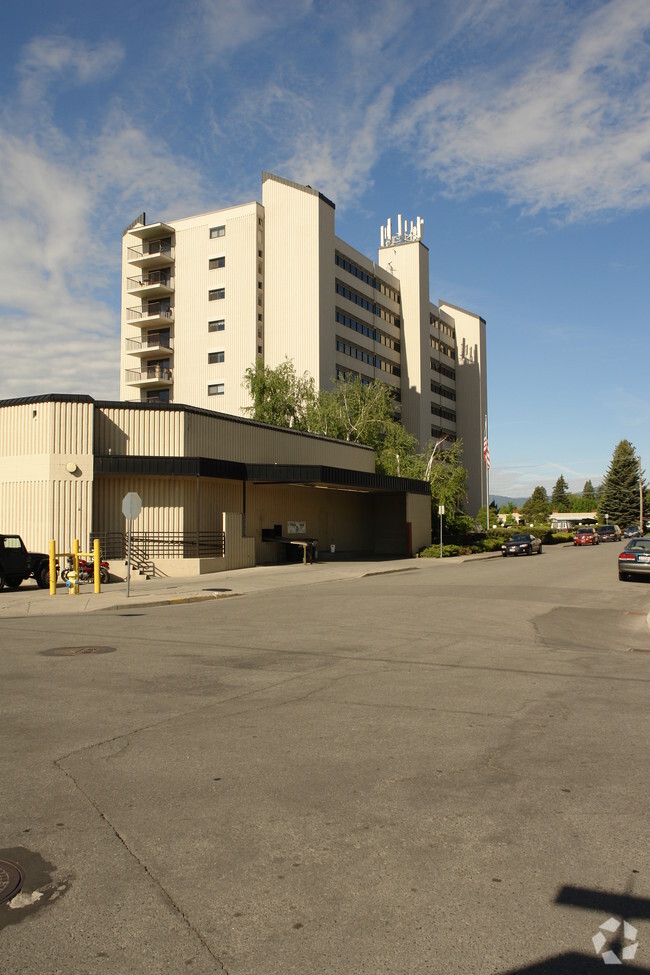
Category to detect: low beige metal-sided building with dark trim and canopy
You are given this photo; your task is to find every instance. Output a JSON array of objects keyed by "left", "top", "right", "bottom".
[{"left": 0, "top": 394, "right": 431, "bottom": 576}]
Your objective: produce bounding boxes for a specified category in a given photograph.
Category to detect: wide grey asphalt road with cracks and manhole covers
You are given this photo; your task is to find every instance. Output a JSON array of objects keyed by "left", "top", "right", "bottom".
[{"left": 0, "top": 545, "right": 650, "bottom": 975}]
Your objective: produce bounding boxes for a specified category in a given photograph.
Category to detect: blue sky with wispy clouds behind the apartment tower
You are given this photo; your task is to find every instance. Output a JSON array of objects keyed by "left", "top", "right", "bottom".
[{"left": 0, "top": 0, "right": 650, "bottom": 496}]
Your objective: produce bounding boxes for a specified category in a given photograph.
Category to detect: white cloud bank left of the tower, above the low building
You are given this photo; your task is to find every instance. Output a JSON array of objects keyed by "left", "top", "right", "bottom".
[{"left": 0, "top": 37, "right": 210, "bottom": 398}]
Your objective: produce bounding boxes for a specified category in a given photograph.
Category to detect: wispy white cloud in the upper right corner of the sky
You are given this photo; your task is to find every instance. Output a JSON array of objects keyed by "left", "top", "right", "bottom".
[{"left": 399, "top": 0, "right": 650, "bottom": 217}]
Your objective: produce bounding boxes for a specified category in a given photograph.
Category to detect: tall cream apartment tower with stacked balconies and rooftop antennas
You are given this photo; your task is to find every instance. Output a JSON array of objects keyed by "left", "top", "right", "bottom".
[{"left": 120, "top": 173, "right": 487, "bottom": 513}]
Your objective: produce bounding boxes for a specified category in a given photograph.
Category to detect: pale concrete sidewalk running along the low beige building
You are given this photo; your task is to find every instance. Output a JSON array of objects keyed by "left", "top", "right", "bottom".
[{"left": 0, "top": 555, "right": 466, "bottom": 619}]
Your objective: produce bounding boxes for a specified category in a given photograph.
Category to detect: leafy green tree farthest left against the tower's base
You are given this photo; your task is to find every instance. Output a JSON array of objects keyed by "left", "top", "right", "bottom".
[{"left": 244, "top": 359, "right": 316, "bottom": 430}]
